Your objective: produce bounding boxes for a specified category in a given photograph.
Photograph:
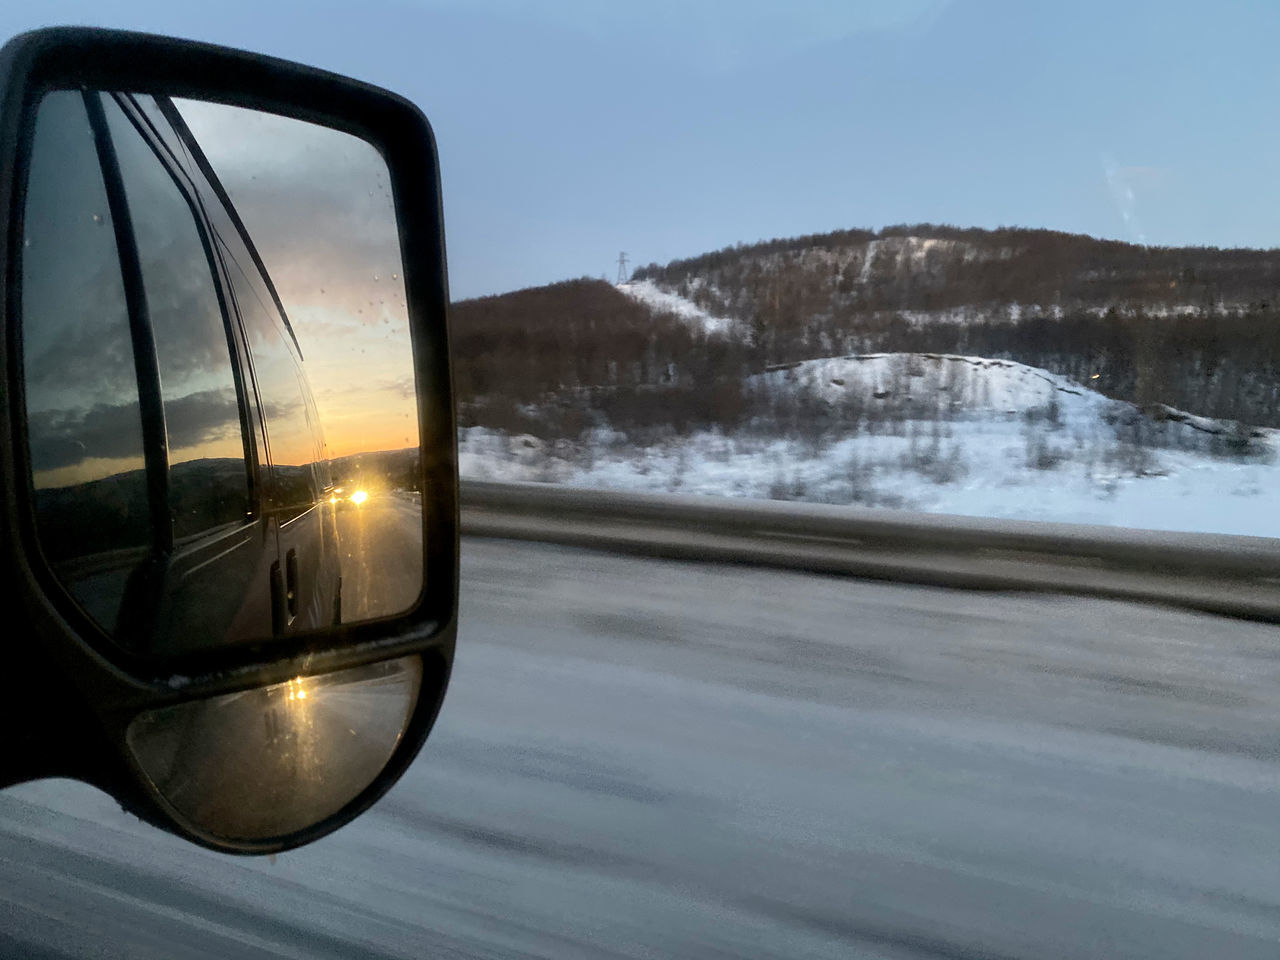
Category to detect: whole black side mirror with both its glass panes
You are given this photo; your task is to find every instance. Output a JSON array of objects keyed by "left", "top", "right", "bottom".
[{"left": 0, "top": 28, "right": 458, "bottom": 852}]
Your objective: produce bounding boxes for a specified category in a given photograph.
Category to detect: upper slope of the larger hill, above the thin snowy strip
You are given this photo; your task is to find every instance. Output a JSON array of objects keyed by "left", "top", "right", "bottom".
[{"left": 632, "top": 224, "right": 1280, "bottom": 319}]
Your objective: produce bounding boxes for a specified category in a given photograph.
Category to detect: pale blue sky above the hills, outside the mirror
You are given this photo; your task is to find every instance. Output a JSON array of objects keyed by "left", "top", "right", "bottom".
[{"left": 0, "top": 0, "right": 1280, "bottom": 297}]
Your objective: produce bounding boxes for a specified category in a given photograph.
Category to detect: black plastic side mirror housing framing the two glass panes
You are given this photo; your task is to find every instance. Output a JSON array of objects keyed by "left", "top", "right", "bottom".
[{"left": 0, "top": 28, "right": 458, "bottom": 854}]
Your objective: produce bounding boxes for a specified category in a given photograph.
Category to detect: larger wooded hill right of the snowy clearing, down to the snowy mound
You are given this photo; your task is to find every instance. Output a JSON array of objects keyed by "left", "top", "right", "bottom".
[{"left": 634, "top": 224, "right": 1280, "bottom": 425}]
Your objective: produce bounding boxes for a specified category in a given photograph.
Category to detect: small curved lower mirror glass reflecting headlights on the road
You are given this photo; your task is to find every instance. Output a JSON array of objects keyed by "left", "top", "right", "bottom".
[{"left": 125, "top": 657, "right": 422, "bottom": 840}]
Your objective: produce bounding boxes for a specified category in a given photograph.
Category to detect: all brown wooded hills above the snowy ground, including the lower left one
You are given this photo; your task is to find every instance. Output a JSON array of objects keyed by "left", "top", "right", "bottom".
[{"left": 453, "top": 224, "right": 1280, "bottom": 431}]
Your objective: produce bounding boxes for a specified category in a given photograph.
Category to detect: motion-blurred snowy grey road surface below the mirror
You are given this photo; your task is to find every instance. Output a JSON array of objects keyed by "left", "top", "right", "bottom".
[{"left": 0, "top": 541, "right": 1280, "bottom": 960}]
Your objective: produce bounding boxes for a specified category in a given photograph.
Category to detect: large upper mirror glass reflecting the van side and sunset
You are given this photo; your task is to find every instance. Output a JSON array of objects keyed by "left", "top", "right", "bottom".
[{"left": 20, "top": 91, "right": 422, "bottom": 655}]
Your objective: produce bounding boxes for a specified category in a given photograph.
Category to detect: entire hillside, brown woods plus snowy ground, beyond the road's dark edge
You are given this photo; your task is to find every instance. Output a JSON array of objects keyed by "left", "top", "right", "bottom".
[{"left": 452, "top": 224, "right": 1280, "bottom": 531}]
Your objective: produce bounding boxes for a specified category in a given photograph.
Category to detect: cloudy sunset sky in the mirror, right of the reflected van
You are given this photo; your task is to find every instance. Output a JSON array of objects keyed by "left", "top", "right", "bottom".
[{"left": 175, "top": 100, "right": 417, "bottom": 457}]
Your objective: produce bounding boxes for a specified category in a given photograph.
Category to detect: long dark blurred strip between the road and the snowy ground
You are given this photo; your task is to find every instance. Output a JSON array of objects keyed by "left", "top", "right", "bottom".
[{"left": 462, "top": 480, "right": 1280, "bottom": 622}]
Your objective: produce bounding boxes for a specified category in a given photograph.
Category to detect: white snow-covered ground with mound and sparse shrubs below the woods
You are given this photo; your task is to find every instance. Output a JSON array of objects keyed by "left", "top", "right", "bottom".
[{"left": 460, "top": 355, "right": 1280, "bottom": 536}]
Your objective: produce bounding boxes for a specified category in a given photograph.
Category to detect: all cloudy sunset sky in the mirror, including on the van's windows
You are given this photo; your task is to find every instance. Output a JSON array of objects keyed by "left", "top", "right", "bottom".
[{"left": 23, "top": 92, "right": 417, "bottom": 488}]
